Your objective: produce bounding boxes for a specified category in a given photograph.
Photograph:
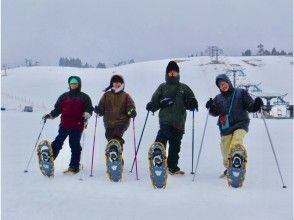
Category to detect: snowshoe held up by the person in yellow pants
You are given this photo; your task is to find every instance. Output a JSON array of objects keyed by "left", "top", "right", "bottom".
[{"left": 227, "top": 145, "right": 247, "bottom": 188}]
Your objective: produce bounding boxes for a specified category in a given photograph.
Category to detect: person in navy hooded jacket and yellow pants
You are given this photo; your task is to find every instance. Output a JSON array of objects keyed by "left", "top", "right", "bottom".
[{"left": 206, "top": 74, "right": 263, "bottom": 176}]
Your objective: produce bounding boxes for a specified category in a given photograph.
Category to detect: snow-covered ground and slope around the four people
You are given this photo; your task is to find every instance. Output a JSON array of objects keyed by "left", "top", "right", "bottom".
[{"left": 1, "top": 57, "right": 293, "bottom": 220}]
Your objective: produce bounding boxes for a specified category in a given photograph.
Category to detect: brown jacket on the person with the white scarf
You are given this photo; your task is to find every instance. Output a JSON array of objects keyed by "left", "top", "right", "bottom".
[{"left": 99, "top": 91, "right": 135, "bottom": 129}]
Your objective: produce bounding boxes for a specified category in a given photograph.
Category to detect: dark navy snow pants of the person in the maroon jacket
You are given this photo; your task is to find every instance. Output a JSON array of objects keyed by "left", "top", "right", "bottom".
[{"left": 52, "top": 126, "right": 83, "bottom": 168}]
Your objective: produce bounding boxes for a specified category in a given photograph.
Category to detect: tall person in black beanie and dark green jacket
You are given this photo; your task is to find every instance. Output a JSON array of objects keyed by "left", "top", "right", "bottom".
[{"left": 146, "top": 61, "right": 198, "bottom": 175}]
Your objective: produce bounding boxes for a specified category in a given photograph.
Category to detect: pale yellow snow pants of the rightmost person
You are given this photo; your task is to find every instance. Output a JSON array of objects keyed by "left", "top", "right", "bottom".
[{"left": 220, "top": 129, "right": 247, "bottom": 168}]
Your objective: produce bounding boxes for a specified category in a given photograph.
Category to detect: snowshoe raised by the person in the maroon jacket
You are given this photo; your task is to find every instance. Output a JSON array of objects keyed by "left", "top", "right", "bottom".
[{"left": 37, "top": 140, "right": 54, "bottom": 177}]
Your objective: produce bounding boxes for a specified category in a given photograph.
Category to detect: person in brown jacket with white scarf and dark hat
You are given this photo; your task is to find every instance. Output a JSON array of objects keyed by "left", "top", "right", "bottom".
[{"left": 94, "top": 74, "right": 137, "bottom": 146}]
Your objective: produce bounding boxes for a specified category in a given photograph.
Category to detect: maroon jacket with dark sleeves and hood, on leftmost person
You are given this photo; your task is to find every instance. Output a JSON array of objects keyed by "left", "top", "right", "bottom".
[{"left": 50, "top": 76, "right": 93, "bottom": 129}]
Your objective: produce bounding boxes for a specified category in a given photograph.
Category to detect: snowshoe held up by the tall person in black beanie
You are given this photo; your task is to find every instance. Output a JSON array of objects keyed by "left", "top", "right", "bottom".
[{"left": 148, "top": 142, "right": 167, "bottom": 188}]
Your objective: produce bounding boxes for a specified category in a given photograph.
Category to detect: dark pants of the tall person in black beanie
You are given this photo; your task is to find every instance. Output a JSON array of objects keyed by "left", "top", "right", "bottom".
[{"left": 155, "top": 125, "right": 184, "bottom": 169}]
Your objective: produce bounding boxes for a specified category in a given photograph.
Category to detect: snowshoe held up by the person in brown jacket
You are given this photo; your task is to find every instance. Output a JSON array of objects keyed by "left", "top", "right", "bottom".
[{"left": 105, "top": 139, "right": 123, "bottom": 182}]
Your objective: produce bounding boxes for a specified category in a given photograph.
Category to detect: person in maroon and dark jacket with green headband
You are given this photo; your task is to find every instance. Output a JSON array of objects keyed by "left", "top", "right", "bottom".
[{"left": 43, "top": 76, "right": 93, "bottom": 174}]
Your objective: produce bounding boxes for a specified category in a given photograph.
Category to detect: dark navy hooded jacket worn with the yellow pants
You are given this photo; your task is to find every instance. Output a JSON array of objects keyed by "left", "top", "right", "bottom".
[{"left": 209, "top": 74, "right": 256, "bottom": 136}]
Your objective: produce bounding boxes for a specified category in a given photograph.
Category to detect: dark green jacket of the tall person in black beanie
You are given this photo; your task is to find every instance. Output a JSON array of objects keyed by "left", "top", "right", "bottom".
[{"left": 151, "top": 72, "right": 195, "bottom": 132}]
